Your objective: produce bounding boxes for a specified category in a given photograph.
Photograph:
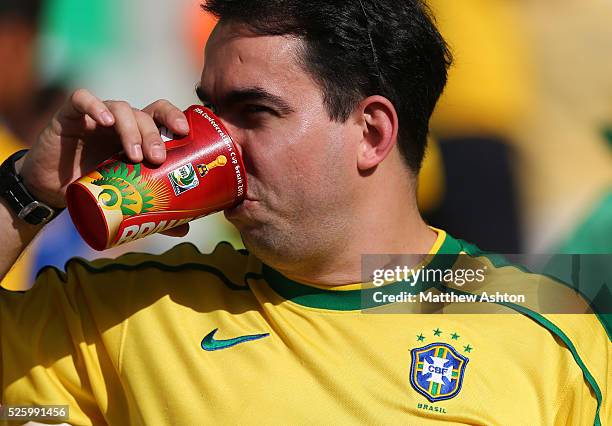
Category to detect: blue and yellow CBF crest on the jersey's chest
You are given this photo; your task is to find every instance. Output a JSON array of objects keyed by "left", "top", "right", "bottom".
[{"left": 410, "top": 343, "right": 469, "bottom": 402}]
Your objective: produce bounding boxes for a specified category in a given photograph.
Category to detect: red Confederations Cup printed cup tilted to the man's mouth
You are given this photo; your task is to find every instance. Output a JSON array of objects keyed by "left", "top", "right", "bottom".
[{"left": 66, "top": 106, "right": 247, "bottom": 250}]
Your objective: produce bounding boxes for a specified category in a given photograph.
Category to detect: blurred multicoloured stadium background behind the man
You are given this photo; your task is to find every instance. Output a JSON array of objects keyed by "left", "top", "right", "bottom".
[{"left": 0, "top": 0, "right": 612, "bottom": 290}]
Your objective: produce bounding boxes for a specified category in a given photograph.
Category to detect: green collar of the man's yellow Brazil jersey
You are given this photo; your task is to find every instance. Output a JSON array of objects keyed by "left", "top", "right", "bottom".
[{"left": 262, "top": 234, "right": 462, "bottom": 311}]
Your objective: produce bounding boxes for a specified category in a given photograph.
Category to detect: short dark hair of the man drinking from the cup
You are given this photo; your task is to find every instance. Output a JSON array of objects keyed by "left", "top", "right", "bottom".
[{"left": 202, "top": 0, "right": 452, "bottom": 173}]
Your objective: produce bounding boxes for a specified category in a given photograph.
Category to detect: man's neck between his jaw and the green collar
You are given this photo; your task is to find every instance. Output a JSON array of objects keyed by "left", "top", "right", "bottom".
[{"left": 271, "top": 154, "right": 437, "bottom": 286}]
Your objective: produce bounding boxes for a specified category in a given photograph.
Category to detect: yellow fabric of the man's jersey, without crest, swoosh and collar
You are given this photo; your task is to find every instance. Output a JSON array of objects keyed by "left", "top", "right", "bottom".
[{"left": 0, "top": 235, "right": 612, "bottom": 425}]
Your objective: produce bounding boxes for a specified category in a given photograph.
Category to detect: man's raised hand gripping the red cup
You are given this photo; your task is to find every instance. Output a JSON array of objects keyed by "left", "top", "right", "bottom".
[{"left": 16, "top": 89, "right": 189, "bottom": 208}]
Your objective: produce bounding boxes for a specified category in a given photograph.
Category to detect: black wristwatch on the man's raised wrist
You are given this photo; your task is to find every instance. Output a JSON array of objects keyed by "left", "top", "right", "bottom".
[{"left": 0, "top": 149, "right": 64, "bottom": 225}]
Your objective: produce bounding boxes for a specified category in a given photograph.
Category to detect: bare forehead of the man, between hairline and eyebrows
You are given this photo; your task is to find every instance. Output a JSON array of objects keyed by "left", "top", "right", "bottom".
[{"left": 201, "top": 23, "right": 313, "bottom": 96}]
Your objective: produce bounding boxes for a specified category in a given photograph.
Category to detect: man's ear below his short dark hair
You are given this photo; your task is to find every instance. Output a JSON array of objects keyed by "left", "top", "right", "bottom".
[{"left": 355, "top": 95, "right": 399, "bottom": 171}]
